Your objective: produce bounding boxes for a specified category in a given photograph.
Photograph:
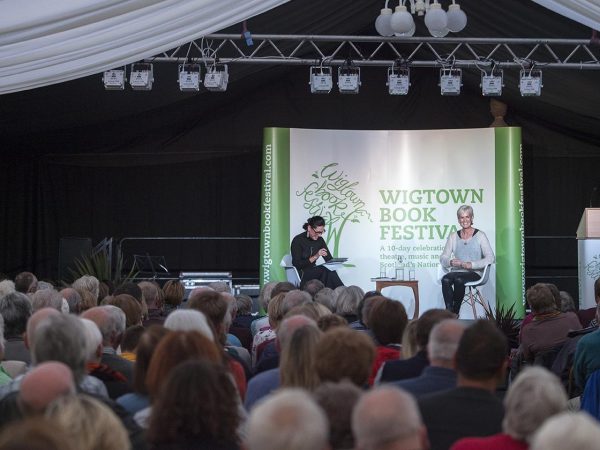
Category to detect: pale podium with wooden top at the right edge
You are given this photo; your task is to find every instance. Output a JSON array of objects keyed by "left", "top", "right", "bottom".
[{"left": 577, "top": 208, "right": 600, "bottom": 309}]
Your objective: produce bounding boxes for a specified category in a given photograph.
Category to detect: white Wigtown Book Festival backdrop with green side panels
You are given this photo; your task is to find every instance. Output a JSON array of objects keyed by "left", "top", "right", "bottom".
[{"left": 261, "top": 128, "right": 523, "bottom": 314}]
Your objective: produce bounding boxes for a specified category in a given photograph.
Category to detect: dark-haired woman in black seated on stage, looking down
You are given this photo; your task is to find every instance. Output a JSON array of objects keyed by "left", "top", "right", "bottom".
[{"left": 291, "top": 216, "right": 344, "bottom": 289}]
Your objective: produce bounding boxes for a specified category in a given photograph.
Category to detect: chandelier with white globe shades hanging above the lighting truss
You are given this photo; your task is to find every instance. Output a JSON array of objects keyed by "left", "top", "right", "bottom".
[{"left": 375, "top": 0, "right": 467, "bottom": 37}]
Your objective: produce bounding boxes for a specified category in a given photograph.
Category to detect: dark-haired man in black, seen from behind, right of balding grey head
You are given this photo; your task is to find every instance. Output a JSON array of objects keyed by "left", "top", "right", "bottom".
[{"left": 419, "top": 320, "right": 508, "bottom": 450}]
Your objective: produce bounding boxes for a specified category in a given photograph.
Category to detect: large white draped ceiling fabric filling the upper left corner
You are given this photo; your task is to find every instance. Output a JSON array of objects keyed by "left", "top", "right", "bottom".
[{"left": 0, "top": 0, "right": 289, "bottom": 94}]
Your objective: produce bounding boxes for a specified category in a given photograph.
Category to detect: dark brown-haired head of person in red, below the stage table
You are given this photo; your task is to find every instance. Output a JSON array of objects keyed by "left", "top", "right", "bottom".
[{"left": 369, "top": 297, "right": 408, "bottom": 345}]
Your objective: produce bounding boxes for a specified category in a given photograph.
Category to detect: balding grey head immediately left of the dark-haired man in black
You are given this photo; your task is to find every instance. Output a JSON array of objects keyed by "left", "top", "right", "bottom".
[{"left": 427, "top": 319, "right": 466, "bottom": 369}]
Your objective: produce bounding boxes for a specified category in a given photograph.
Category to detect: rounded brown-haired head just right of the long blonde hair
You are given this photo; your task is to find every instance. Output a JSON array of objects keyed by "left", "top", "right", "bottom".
[{"left": 315, "top": 327, "right": 375, "bottom": 387}]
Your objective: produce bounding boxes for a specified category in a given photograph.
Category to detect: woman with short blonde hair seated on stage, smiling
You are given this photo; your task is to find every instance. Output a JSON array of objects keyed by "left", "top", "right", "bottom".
[{"left": 440, "top": 205, "right": 495, "bottom": 314}]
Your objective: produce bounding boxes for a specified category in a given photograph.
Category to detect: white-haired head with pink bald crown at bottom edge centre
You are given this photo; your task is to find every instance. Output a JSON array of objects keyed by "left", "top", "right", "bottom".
[{"left": 245, "top": 388, "right": 329, "bottom": 450}]
